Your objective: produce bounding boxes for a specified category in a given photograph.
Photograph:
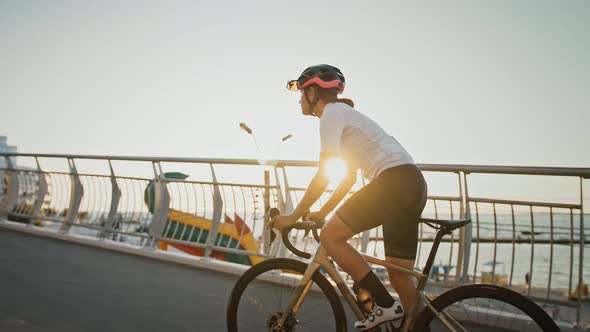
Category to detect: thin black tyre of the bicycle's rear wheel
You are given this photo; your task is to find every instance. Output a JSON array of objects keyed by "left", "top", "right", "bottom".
[{"left": 412, "top": 284, "right": 560, "bottom": 332}]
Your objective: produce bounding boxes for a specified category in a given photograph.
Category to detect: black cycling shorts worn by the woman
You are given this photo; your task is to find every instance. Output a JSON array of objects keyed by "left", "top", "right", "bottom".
[{"left": 336, "top": 164, "right": 427, "bottom": 259}]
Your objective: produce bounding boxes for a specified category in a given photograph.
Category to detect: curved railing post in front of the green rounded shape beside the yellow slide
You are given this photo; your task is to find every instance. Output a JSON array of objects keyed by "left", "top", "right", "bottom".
[{"left": 147, "top": 162, "right": 170, "bottom": 249}]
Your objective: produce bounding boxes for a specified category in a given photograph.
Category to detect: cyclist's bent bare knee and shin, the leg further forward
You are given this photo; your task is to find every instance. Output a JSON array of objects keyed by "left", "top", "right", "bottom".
[{"left": 320, "top": 213, "right": 371, "bottom": 281}]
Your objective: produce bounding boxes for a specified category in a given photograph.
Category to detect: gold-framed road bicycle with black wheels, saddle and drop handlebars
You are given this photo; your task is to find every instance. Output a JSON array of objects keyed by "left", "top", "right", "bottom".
[{"left": 226, "top": 209, "right": 559, "bottom": 332}]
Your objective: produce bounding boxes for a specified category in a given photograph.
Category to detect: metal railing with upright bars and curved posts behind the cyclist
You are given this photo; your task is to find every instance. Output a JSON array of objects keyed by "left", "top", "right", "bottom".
[{"left": 0, "top": 154, "right": 590, "bottom": 322}]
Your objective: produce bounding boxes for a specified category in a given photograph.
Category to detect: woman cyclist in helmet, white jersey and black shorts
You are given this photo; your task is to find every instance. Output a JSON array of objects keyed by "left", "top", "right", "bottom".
[{"left": 268, "top": 64, "right": 427, "bottom": 330}]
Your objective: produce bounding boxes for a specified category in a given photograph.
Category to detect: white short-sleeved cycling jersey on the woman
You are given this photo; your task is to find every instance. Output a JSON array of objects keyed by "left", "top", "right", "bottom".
[{"left": 320, "top": 103, "right": 414, "bottom": 181}]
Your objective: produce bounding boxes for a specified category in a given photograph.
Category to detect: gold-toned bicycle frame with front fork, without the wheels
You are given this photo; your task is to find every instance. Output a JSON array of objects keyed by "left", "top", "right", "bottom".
[{"left": 277, "top": 244, "right": 465, "bottom": 332}]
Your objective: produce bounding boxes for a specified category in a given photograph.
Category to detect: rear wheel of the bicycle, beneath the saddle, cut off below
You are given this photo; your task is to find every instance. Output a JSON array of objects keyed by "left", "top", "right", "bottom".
[{"left": 413, "top": 284, "right": 559, "bottom": 332}]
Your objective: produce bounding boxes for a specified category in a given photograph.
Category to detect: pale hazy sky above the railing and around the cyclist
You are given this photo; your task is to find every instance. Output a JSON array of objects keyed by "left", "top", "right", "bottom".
[{"left": 0, "top": 0, "right": 590, "bottom": 202}]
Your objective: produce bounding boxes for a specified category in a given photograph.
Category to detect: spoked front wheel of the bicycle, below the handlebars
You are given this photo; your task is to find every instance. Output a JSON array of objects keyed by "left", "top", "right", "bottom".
[{"left": 227, "top": 258, "right": 346, "bottom": 332}]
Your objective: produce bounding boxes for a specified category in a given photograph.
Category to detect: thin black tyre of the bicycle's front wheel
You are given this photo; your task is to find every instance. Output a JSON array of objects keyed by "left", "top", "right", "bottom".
[{"left": 226, "top": 258, "right": 346, "bottom": 332}]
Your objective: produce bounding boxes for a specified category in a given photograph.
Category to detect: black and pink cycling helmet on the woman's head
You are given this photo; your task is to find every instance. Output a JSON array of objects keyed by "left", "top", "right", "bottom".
[{"left": 287, "top": 65, "right": 345, "bottom": 94}]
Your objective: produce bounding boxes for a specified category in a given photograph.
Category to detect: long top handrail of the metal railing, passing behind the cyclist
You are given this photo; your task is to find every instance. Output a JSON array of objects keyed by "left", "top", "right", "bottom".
[{"left": 0, "top": 153, "right": 590, "bottom": 179}]
